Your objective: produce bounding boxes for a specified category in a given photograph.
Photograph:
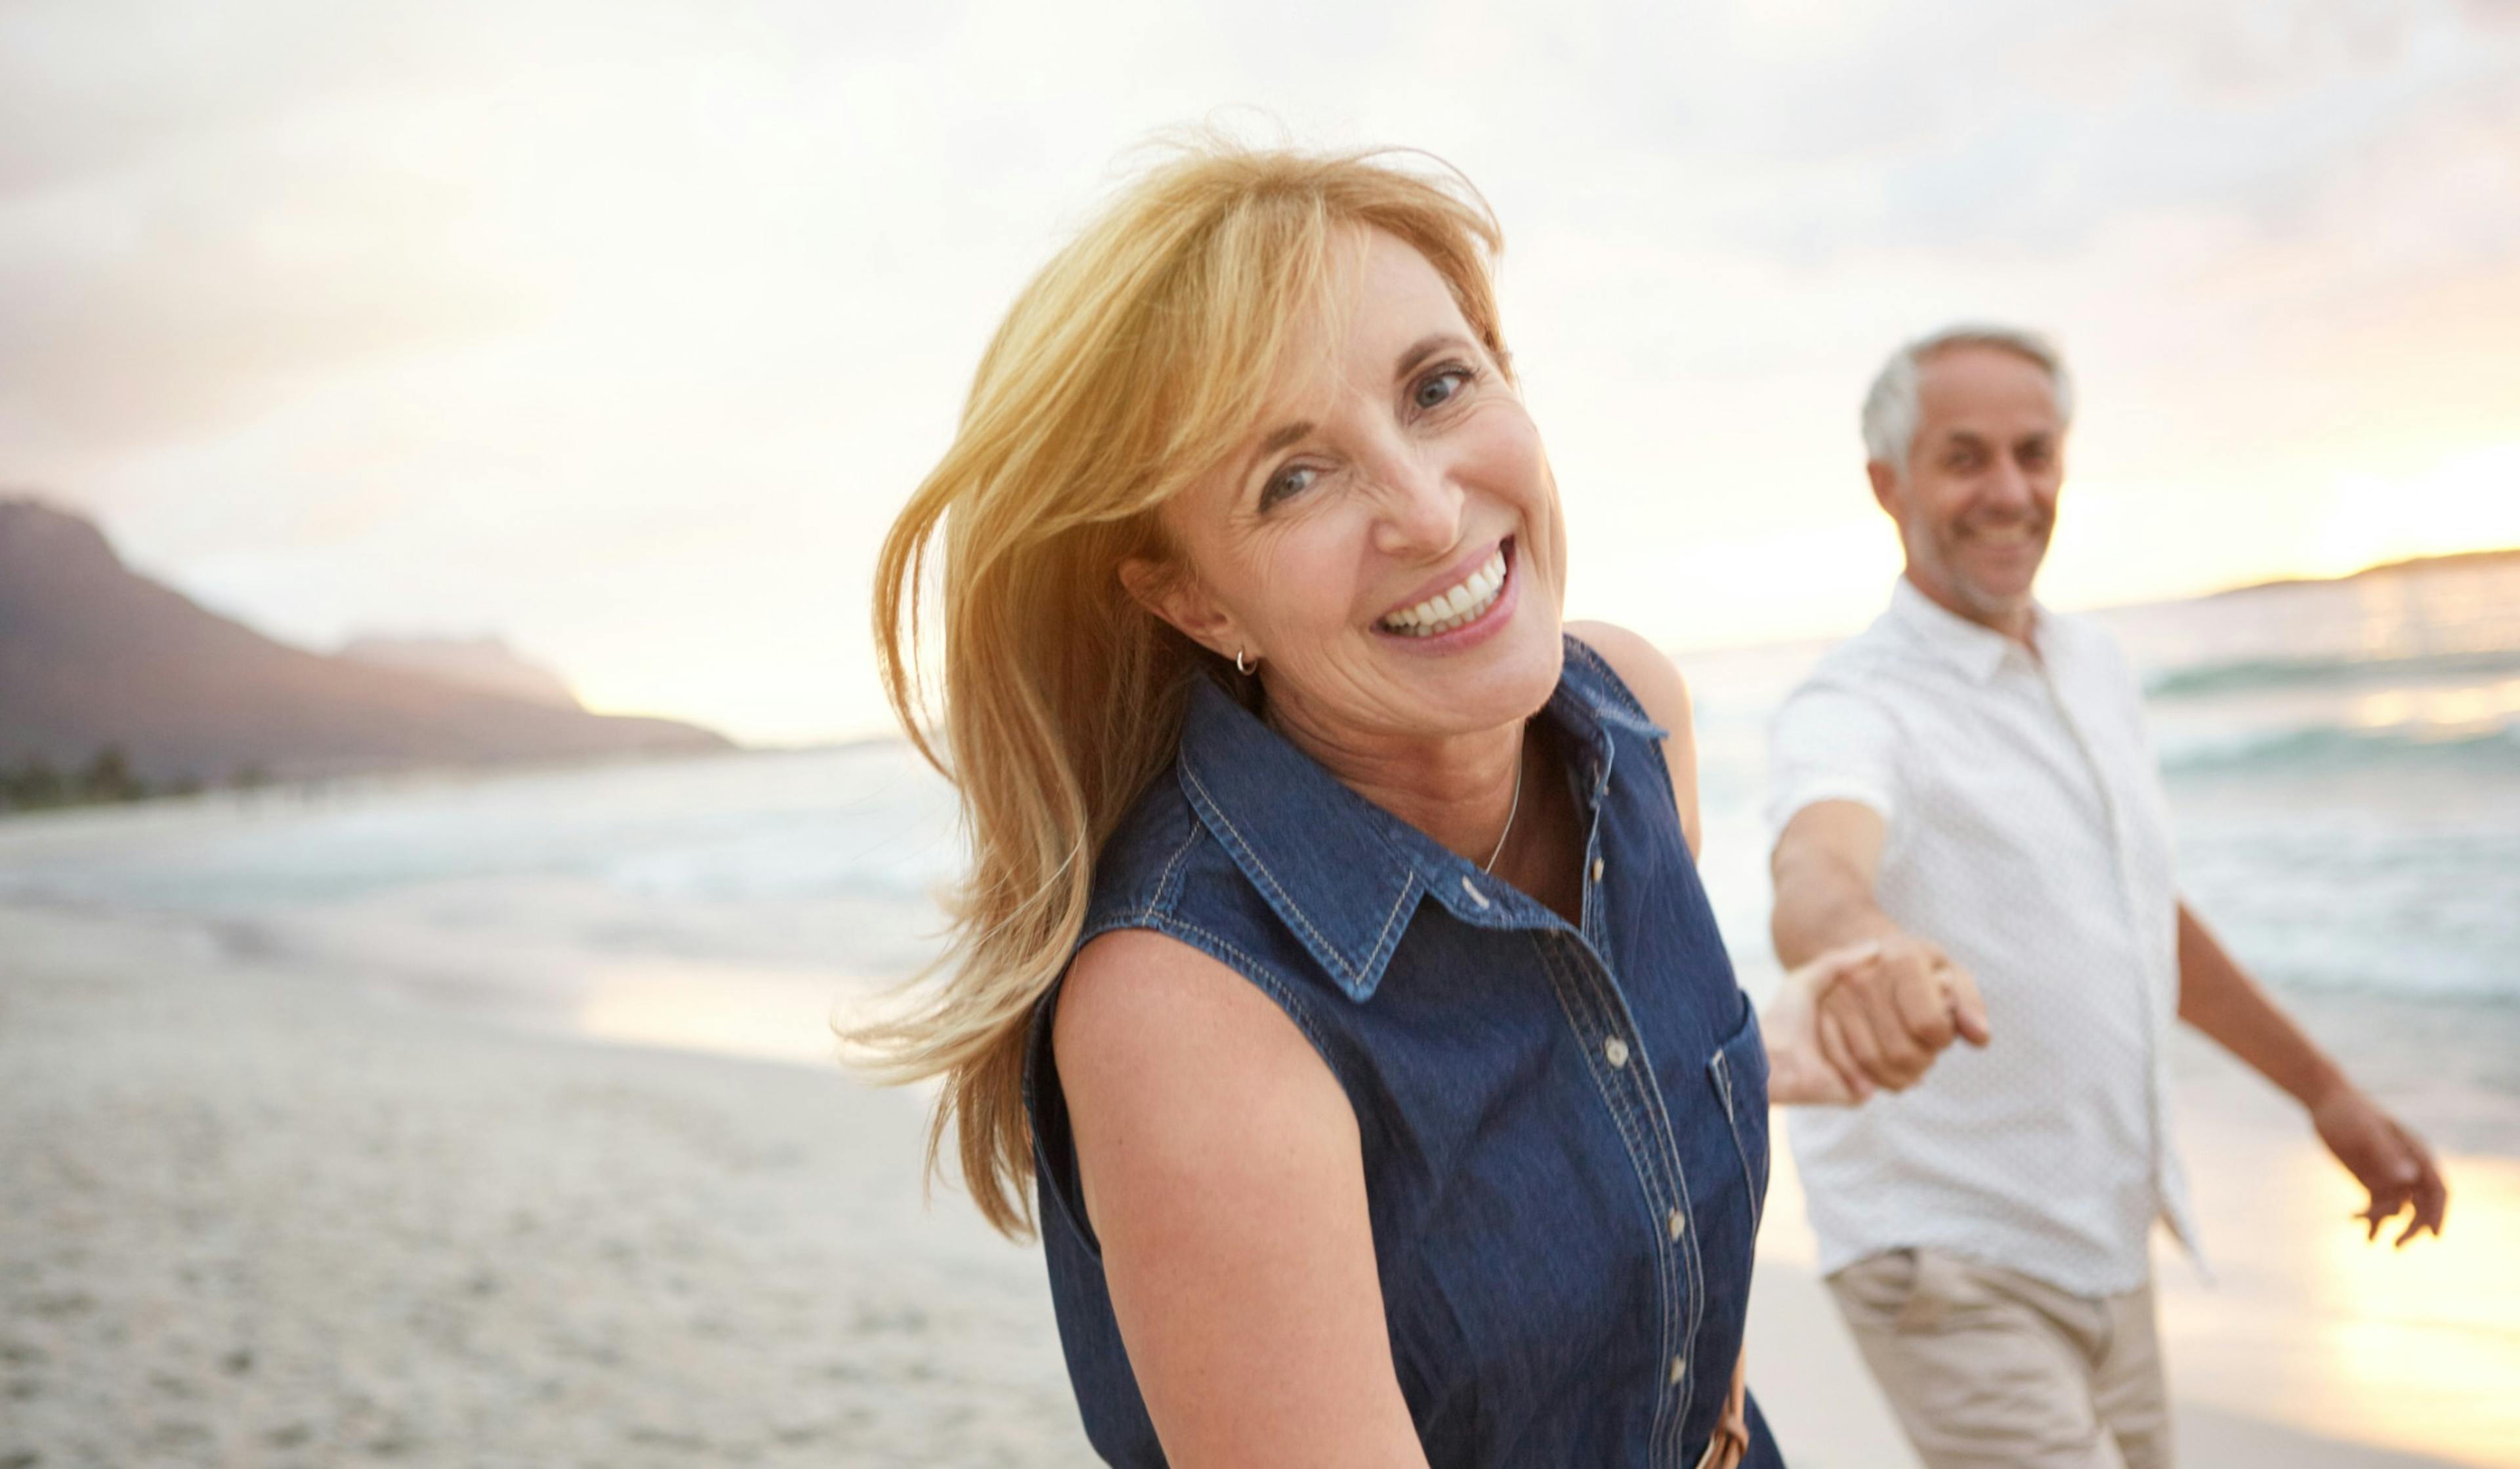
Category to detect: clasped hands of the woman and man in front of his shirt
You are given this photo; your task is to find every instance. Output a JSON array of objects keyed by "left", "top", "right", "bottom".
[{"left": 1761, "top": 935, "right": 1988, "bottom": 1106}]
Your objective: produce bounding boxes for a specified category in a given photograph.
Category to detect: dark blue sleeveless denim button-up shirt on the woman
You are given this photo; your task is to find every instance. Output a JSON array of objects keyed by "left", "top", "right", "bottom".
[{"left": 1026, "top": 638, "right": 1782, "bottom": 1469}]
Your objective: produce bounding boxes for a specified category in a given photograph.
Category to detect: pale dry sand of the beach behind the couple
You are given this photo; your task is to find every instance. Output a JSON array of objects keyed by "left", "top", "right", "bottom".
[{"left": 0, "top": 907, "right": 2520, "bottom": 1469}]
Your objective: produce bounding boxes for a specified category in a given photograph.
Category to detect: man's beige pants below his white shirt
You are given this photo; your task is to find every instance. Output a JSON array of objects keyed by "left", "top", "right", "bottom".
[{"left": 1830, "top": 1250, "right": 2172, "bottom": 1469}]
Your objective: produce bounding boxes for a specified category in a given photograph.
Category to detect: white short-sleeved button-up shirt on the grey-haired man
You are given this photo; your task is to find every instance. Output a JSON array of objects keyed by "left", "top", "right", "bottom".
[{"left": 1769, "top": 577, "right": 2195, "bottom": 1295}]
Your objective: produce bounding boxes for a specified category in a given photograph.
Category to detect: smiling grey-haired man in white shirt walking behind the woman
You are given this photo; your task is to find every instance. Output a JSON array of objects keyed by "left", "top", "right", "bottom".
[{"left": 1772, "top": 327, "right": 2447, "bottom": 1469}]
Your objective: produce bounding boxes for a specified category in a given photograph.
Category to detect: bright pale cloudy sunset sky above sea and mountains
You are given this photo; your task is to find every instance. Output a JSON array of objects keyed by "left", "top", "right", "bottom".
[{"left": 0, "top": 0, "right": 2520, "bottom": 741}]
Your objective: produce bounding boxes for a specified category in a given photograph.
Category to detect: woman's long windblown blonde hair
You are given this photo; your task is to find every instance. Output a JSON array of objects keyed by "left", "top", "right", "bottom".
[{"left": 844, "top": 138, "right": 1507, "bottom": 1237}]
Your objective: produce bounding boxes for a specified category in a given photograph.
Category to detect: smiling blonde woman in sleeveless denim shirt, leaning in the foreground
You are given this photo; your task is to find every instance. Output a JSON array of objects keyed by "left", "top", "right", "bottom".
[{"left": 862, "top": 146, "right": 1985, "bottom": 1466}]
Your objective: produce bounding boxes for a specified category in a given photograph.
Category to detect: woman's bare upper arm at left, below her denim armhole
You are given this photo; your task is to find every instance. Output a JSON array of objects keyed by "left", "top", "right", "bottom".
[{"left": 1051, "top": 930, "right": 1426, "bottom": 1469}]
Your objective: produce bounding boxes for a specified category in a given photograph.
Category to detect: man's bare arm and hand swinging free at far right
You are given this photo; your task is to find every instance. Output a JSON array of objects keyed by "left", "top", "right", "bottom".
[{"left": 2180, "top": 902, "right": 2449, "bottom": 1245}]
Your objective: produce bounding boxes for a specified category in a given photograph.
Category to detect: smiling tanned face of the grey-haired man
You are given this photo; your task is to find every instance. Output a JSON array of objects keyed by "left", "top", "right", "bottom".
[{"left": 1867, "top": 345, "right": 2064, "bottom": 635}]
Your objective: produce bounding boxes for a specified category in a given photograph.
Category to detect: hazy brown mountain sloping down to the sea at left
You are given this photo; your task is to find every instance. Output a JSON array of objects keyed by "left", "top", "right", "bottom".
[{"left": 0, "top": 499, "right": 731, "bottom": 783}]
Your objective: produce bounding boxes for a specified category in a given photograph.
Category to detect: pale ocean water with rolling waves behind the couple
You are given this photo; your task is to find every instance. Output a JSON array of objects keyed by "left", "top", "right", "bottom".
[{"left": 0, "top": 557, "right": 2520, "bottom": 1138}]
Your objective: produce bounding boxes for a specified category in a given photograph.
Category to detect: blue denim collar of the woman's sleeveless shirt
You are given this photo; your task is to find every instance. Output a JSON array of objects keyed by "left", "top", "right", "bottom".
[{"left": 1177, "top": 640, "right": 1633, "bottom": 1003}]
